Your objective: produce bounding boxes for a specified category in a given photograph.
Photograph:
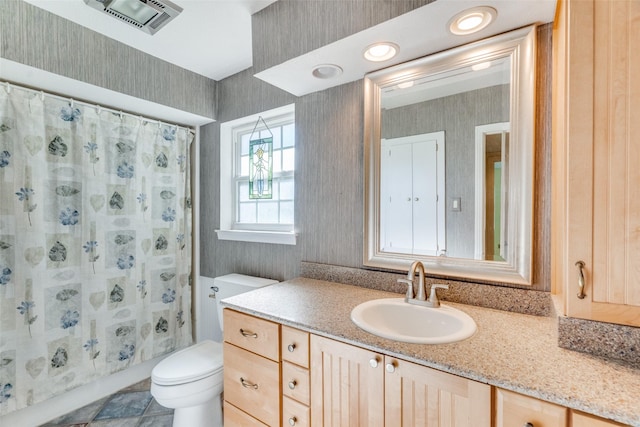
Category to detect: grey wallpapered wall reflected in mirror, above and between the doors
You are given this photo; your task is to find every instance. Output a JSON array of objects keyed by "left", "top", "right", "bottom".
[{"left": 382, "top": 85, "right": 509, "bottom": 259}]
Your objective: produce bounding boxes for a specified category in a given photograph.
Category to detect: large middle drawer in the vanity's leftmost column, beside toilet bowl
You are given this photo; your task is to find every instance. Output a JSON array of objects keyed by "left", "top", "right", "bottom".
[{"left": 224, "top": 343, "right": 280, "bottom": 426}]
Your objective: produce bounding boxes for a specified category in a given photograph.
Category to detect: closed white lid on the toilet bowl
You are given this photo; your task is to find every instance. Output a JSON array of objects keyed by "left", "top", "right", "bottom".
[{"left": 151, "top": 340, "right": 222, "bottom": 385}]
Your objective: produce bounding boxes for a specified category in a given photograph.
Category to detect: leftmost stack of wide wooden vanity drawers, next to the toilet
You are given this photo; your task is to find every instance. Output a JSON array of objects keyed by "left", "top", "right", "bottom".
[{"left": 224, "top": 309, "right": 281, "bottom": 427}]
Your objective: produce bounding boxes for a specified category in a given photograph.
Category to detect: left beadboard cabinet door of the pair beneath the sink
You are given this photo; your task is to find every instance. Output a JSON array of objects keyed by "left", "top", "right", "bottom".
[{"left": 311, "top": 335, "right": 384, "bottom": 427}]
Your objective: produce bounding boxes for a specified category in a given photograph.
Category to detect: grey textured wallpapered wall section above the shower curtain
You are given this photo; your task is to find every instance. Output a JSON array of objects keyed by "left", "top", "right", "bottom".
[{"left": 0, "top": 0, "right": 216, "bottom": 119}]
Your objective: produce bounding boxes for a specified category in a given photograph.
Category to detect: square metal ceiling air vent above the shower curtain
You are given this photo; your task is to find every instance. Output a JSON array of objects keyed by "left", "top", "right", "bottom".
[{"left": 84, "top": 0, "right": 182, "bottom": 34}]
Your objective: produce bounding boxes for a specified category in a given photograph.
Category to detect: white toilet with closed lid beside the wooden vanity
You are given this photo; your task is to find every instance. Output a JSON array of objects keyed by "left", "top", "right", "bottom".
[{"left": 151, "top": 274, "right": 277, "bottom": 427}]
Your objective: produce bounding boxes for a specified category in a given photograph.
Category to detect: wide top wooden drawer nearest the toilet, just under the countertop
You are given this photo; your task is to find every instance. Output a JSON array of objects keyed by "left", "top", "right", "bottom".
[{"left": 224, "top": 308, "right": 280, "bottom": 362}]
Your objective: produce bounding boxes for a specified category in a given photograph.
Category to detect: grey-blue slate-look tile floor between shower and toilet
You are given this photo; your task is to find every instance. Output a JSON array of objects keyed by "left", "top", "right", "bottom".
[{"left": 41, "top": 379, "right": 173, "bottom": 427}]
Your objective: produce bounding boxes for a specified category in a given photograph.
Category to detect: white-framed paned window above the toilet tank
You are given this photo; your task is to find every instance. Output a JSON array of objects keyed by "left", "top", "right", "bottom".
[{"left": 217, "top": 105, "right": 295, "bottom": 244}]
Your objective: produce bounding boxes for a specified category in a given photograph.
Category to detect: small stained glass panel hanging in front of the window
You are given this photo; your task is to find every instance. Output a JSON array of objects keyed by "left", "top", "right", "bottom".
[{"left": 249, "top": 138, "right": 273, "bottom": 199}]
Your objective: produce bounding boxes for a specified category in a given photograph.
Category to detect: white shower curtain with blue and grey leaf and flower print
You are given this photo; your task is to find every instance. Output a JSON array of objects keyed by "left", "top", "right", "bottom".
[{"left": 0, "top": 85, "right": 193, "bottom": 415}]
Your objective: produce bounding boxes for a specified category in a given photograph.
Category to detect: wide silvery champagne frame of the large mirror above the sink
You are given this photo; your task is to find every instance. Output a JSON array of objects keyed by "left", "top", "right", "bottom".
[{"left": 363, "top": 26, "right": 536, "bottom": 286}]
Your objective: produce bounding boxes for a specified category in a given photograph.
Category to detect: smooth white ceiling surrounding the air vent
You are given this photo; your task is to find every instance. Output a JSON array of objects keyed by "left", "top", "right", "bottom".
[{"left": 25, "top": 0, "right": 276, "bottom": 80}]
